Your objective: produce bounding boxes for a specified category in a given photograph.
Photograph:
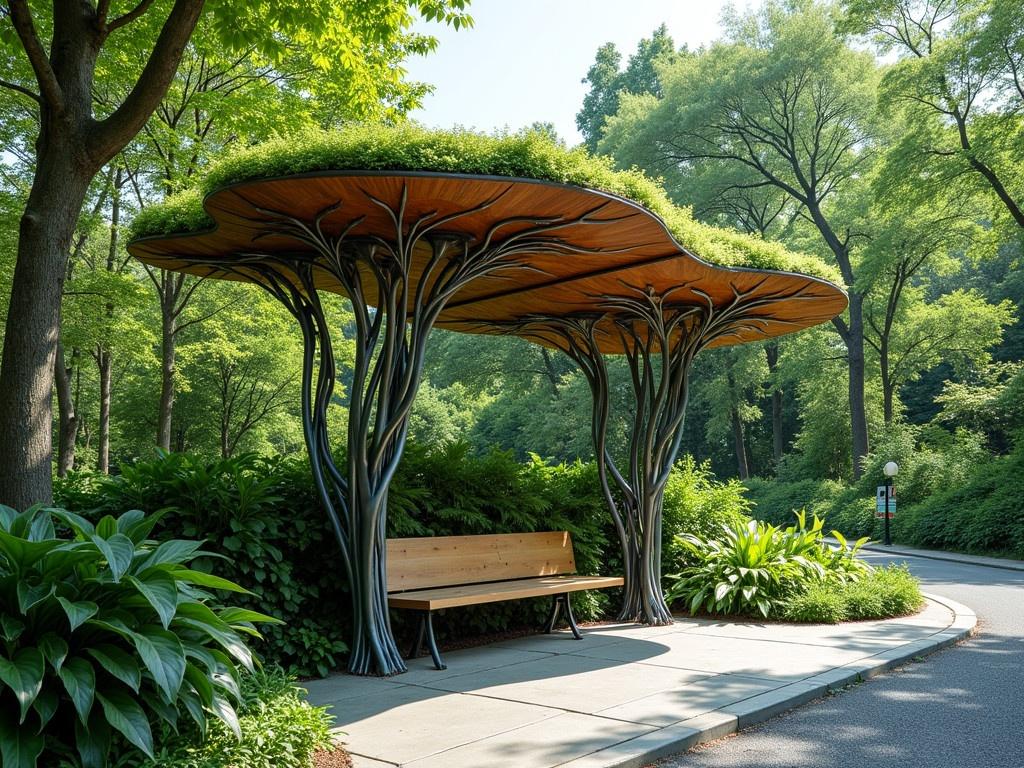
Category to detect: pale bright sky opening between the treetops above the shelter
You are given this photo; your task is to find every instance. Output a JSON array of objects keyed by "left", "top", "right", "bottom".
[{"left": 407, "top": 0, "right": 750, "bottom": 144}]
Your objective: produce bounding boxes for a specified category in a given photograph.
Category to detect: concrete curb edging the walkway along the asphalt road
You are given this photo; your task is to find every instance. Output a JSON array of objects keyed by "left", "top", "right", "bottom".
[{"left": 559, "top": 593, "right": 978, "bottom": 768}]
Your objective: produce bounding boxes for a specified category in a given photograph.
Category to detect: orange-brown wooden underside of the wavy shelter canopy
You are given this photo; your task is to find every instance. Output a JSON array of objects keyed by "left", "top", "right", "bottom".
[{"left": 128, "top": 171, "right": 847, "bottom": 351}]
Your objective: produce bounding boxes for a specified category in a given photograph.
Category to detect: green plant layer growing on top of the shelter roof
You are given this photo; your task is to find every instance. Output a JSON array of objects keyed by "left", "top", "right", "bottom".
[{"left": 131, "top": 124, "right": 840, "bottom": 283}]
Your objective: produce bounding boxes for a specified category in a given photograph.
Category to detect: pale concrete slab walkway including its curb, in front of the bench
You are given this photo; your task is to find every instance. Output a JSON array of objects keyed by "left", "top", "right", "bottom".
[{"left": 307, "top": 596, "right": 976, "bottom": 768}]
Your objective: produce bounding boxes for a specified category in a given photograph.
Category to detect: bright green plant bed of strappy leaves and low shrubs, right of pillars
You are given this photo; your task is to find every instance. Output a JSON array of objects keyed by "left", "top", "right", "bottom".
[{"left": 666, "top": 512, "right": 922, "bottom": 623}]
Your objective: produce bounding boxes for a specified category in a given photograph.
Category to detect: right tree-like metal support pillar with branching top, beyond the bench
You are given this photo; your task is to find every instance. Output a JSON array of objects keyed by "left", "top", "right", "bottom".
[{"left": 532, "top": 285, "right": 803, "bottom": 625}]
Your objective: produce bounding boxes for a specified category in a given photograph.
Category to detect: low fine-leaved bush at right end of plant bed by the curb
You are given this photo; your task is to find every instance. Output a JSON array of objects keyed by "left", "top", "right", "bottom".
[{"left": 782, "top": 565, "right": 925, "bottom": 624}]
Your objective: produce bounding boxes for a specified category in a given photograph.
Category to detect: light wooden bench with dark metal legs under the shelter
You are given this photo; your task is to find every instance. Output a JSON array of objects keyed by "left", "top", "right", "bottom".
[{"left": 387, "top": 530, "right": 623, "bottom": 670}]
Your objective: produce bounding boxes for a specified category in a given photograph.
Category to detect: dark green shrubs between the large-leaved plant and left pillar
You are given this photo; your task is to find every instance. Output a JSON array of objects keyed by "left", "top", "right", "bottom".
[{"left": 55, "top": 454, "right": 346, "bottom": 675}]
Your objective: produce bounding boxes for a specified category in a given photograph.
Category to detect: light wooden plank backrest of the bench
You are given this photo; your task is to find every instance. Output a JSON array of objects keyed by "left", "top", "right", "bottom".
[{"left": 387, "top": 530, "right": 575, "bottom": 592}]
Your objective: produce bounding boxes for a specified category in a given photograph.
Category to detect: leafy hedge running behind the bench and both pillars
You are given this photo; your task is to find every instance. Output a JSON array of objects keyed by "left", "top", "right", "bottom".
[{"left": 55, "top": 442, "right": 770, "bottom": 676}]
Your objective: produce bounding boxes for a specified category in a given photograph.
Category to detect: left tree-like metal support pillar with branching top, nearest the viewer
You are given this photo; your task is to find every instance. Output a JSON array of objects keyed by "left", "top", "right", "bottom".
[{"left": 176, "top": 187, "right": 614, "bottom": 675}]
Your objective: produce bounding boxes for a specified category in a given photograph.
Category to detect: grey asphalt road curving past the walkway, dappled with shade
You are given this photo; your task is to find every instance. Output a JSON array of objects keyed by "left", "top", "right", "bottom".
[{"left": 656, "top": 554, "right": 1024, "bottom": 768}]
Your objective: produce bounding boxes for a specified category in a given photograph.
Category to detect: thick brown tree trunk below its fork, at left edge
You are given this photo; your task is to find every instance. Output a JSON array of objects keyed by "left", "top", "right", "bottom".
[{"left": 0, "top": 147, "right": 94, "bottom": 509}]
